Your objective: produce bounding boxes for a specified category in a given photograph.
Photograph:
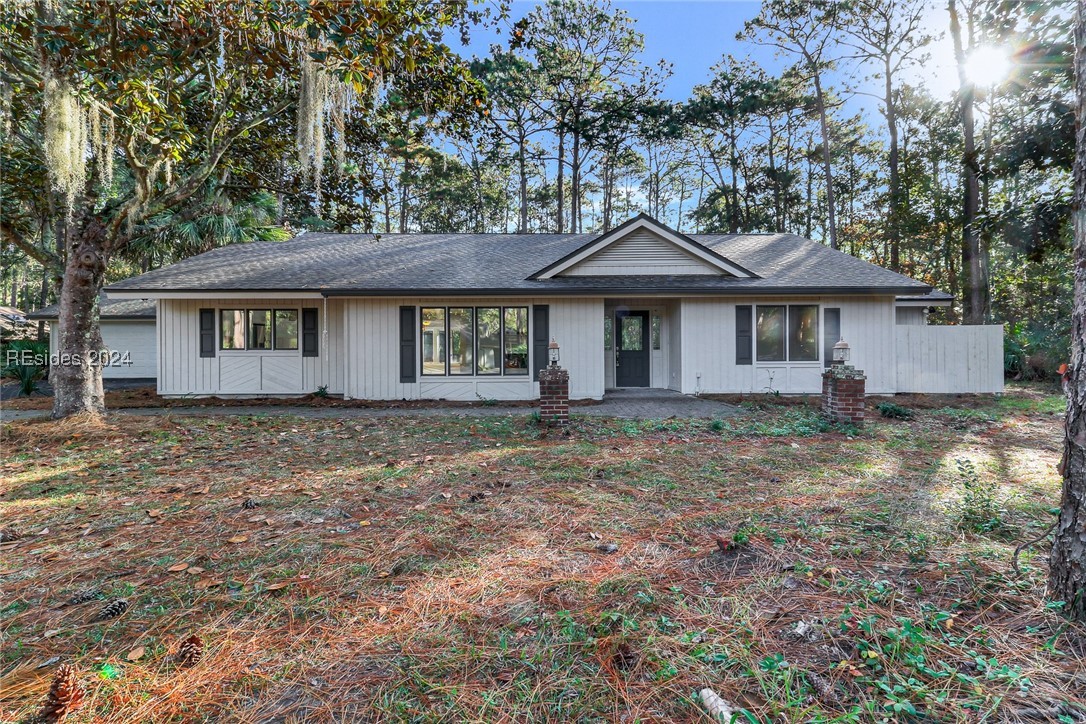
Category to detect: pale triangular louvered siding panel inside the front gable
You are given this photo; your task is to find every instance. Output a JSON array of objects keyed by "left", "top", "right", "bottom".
[{"left": 559, "top": 229, "right": 722, "bottom": 277}]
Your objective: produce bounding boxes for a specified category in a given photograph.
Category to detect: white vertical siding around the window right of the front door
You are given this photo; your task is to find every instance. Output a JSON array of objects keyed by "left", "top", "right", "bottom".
[{"left": 680, "top": 296, "right": 897, "bottom": 394}]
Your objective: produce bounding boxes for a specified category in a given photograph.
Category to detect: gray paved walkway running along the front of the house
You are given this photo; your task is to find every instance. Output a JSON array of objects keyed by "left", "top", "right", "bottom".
[{"left": 0, "top": 389, "right": 742, "bottom": 422}]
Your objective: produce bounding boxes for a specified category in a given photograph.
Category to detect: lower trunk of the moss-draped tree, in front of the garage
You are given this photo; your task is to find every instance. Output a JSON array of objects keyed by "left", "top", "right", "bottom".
[{"left": 49, "top": 217, "right": 106, "bottom": 418}]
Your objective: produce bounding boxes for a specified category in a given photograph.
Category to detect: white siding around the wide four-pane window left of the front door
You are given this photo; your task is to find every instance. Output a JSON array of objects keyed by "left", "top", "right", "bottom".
[{"left": 343, "top": 297, "right": 604, "bottom": 402}]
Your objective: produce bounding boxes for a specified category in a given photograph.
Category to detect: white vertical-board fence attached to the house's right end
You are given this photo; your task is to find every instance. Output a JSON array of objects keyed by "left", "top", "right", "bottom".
[{"left": 894, "top": 325, "right": 1003, "bottom": 393}]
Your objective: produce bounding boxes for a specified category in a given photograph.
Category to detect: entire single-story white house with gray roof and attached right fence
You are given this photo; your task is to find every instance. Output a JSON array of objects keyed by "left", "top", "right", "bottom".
[{"left": 106, "top": 215, "right": 1002, "bottom": 401}]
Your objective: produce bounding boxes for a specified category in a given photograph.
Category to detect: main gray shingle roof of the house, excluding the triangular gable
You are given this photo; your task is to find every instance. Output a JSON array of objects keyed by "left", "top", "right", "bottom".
[{"left": 108, "top": 226, "right": 931, "bottom": 296}]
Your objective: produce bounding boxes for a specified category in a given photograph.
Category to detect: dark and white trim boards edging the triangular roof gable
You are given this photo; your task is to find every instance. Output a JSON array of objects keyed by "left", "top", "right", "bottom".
[{"left": 529, "top": 214, "right": 757, "bottom": 279}]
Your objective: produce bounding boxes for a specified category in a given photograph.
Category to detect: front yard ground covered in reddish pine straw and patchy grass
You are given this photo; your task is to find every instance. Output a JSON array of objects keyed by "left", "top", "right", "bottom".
[{"left": 0, "top": 389, "right": 1086, "bottom": 722}]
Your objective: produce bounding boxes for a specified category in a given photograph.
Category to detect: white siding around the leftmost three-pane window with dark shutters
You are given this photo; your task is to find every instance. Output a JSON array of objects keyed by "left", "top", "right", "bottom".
[{"left": 157, "top": 299, "right": 343, "bottom": 396}]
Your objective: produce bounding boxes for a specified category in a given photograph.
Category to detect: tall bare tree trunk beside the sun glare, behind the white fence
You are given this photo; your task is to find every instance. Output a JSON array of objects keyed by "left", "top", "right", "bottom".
[{"left": 947, "top": 0, "right": 989, "bottom": 325}]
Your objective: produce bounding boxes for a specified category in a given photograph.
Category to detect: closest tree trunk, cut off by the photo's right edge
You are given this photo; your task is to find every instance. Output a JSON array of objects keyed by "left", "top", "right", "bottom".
[{"left": 1048, "top": 0, "right": 1086, "bottom": 621}]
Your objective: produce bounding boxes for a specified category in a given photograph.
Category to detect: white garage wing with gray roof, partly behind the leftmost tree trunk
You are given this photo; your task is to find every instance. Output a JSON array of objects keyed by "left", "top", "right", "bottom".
[{"left": 29, "top": 294, "right": 159, "bottom": 380}]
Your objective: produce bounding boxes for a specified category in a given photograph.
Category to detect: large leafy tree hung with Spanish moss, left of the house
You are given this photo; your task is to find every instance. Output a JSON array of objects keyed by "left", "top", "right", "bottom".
[{"left": 0, "top": 0, "right": 483, "bottom": 417}]
